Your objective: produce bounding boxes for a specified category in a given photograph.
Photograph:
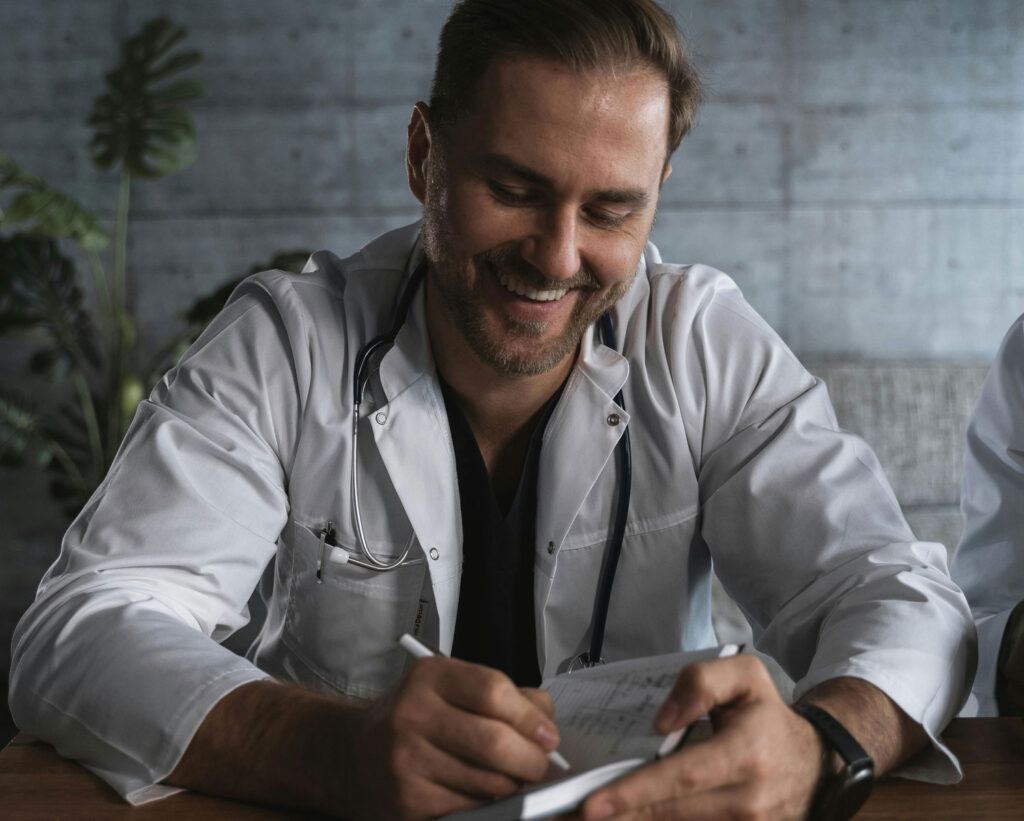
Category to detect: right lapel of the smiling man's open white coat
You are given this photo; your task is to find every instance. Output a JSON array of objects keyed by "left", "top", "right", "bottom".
[{"left": 534, "top": 328, "right": 630, "bottom": 669}]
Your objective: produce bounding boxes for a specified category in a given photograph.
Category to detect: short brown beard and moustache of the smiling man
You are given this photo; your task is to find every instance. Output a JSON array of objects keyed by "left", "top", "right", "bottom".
[{"left": 423, "top": 213, "right": 633, "bottom": 377}]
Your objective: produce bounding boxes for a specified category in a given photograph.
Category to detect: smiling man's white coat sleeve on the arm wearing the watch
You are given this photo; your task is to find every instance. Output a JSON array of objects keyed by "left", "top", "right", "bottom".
[{"left": 689, "top": 284, "right": 976, "bottom": 782}]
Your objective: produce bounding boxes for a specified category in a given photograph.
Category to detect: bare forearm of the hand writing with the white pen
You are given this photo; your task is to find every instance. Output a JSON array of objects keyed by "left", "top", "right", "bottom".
[{"left": 165, "top": 681, "right": 362, "bottom": 814}]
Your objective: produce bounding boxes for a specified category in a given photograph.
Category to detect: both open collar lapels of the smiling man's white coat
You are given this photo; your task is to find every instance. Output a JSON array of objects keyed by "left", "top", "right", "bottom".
[{"left": 373, "top": 233, "right": 638, "bottom": 664}]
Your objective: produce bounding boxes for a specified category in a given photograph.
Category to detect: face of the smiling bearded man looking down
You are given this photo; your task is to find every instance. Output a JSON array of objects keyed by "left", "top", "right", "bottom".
[{"left": 410, "top": 57, "right": 669, "bottom": 375}]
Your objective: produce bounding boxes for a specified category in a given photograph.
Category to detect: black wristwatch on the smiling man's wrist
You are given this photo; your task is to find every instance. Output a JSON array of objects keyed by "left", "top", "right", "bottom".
[{"left": 793, "top": 704, "right": 874, "bottom": 821}]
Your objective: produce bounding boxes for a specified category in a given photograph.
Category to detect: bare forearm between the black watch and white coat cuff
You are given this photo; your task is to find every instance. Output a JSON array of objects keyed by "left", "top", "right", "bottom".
[{"left": 799, "top": 678, "right": 928, "bottom": 776}]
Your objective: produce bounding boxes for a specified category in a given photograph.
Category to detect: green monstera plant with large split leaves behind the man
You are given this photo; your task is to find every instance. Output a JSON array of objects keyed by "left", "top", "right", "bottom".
[{"left": 0, "top": 17, "right": 298, "bottom": 512}]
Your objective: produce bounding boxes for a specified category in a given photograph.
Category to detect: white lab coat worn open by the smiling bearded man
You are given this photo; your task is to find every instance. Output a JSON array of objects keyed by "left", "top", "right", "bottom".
[{"left": 11, "top": 225, "right": 975, "bottom": 802}]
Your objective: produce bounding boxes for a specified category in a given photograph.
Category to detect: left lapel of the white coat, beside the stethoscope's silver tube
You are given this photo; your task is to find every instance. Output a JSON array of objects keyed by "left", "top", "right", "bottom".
[{"left": 374, "top": 278, "right": 462, "bottom": 653}]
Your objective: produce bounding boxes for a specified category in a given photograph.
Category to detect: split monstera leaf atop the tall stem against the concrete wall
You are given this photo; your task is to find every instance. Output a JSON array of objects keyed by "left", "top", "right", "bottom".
[{"left": 88, "top": 17, "right": 203, "bottom": 179}]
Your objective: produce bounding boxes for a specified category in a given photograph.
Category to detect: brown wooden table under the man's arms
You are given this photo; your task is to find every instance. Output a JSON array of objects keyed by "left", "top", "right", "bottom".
[{"left": 0, "top": 719, "right": 1024, "bottom": 821}]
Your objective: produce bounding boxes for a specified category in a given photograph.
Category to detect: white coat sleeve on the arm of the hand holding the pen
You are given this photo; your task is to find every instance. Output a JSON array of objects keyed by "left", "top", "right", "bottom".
[{"left": 10, "top": 283, "right": 303, "bottom": 803}]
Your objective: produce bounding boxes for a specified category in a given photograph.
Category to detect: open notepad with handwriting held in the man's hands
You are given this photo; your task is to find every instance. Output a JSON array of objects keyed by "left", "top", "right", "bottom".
[{"left": 447, "top": 644, "right": 739, "bottom": 821}]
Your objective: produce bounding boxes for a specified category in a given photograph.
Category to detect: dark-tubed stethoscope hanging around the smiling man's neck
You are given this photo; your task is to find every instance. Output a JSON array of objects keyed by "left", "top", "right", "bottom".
[{"left": 346, "top": 253, "right": 633, "bottom": 671}]
